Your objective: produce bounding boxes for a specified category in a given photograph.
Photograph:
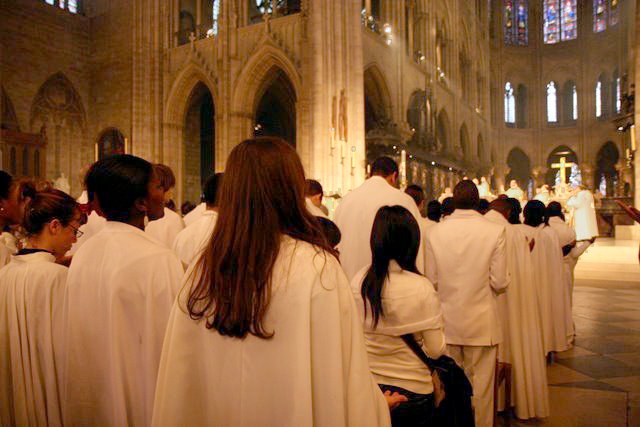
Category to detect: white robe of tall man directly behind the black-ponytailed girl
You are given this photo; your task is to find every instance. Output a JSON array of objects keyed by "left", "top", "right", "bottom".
[{"left": 334, "top": 176, "right": 424, "bottom": 280}]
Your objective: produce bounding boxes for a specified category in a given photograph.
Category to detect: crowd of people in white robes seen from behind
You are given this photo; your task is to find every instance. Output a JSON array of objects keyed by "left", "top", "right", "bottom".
[{"left": 0, "top": 137, "right": 597, "bottom": 426}]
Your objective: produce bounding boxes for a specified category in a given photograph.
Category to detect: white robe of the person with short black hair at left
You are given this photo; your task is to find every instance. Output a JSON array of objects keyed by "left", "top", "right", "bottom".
[{"left": 62, "top": 221, "right": 183, "bottom": 426}]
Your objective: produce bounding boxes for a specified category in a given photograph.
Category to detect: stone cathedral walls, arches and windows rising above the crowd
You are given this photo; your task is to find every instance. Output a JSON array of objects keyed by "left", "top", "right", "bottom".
[{"left": 0, "top": 0, "right": 638, "bottom": 235}]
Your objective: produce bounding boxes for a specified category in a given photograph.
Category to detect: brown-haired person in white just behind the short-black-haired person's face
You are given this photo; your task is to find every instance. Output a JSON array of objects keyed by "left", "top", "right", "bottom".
[{"left": 144, "top": 164, "right": 184, "bottom": 248}]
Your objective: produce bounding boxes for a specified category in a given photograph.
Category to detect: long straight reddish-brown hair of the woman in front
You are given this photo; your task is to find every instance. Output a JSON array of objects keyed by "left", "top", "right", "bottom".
[{"left": 187, "top": 137, "right": 336, "bottom": 338}]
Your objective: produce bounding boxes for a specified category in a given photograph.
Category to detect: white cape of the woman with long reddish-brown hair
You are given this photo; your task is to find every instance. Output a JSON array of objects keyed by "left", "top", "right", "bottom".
[{"left": 153, "top": 237, "right": 390, "bottom": 427}]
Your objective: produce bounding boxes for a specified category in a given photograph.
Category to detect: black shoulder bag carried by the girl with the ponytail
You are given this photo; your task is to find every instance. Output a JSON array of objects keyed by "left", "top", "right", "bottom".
[{"left": 402, "top": 334, "right": 475, "bottom": 427}]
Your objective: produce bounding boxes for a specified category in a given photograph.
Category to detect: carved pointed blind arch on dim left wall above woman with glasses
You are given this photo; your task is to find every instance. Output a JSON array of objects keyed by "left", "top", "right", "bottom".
[{"left": 30, "top": 72, "right": 86, "bottom": 193}]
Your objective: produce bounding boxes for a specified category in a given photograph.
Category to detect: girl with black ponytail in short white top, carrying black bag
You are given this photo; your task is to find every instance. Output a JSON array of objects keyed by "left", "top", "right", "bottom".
[{"left": 351, "top": 206, "right": 445, "bottom": 427}]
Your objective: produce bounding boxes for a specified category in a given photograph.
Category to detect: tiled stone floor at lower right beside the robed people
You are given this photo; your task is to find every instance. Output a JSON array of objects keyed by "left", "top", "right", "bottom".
[{"left": 500, "top": 280, "right": 640, "bottom": 427}]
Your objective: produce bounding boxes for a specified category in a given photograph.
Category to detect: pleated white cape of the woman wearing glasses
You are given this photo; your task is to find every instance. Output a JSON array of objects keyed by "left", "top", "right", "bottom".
[{"left": 0, "top": 252, "right": 67, "bottom": 426}]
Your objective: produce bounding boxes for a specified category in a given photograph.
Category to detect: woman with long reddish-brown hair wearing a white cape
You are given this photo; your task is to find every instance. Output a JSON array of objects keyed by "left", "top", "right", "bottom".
[{"left": 153, "top": 137, "right": 389, "bottom": 427}]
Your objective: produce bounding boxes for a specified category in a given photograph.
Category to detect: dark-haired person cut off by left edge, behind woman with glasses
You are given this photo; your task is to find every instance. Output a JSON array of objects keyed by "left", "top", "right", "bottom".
[{"left": 0, "top": 170, "right": 34, "bottom": 267}]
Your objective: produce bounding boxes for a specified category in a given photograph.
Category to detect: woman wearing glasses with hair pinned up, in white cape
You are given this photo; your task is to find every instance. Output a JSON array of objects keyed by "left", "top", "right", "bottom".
[{"left": 0, "top": 189, "right": 82, "bottom": 425}]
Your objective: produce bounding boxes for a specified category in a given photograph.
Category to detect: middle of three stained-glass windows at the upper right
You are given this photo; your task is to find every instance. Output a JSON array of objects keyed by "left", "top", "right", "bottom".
[{"left": 543, "top": 0, "right": 578, "bottom": 44}]
